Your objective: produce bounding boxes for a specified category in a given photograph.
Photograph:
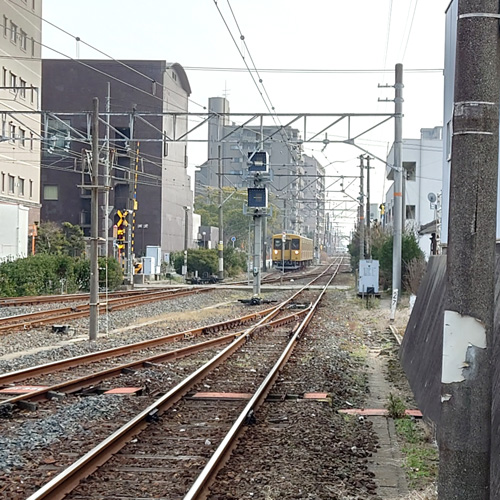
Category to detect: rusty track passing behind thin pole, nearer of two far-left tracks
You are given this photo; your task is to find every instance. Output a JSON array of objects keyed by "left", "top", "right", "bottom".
[{"left": 0, "top": 287, "right": 213, "bottom": 333}]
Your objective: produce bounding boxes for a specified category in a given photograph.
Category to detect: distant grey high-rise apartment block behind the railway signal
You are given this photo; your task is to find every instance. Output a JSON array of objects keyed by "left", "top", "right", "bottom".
[{"left": 195, "top": 97, "right": 325, "bottom": 239}]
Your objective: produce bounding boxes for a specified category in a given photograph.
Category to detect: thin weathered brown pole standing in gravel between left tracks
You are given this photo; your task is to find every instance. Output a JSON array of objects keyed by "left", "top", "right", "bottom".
[{"left": 89, "top": 97, "right": 99, "bottom": 342}]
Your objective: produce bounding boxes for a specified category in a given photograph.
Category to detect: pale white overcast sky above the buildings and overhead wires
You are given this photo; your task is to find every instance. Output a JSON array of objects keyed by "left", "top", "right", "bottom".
[{"left": 43, "top": 0, "right": 449, "bottom": 227}]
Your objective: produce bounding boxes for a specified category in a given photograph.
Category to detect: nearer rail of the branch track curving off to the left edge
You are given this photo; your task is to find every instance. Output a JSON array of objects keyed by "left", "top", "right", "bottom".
[{"left": 0, "top": 309, "right": 308, "bottom": 406}]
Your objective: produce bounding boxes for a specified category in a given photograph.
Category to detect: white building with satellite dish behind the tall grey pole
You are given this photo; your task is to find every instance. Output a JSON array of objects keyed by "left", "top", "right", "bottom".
[{"left": 385, "top": 127, "right": 443, "bottom": 257}]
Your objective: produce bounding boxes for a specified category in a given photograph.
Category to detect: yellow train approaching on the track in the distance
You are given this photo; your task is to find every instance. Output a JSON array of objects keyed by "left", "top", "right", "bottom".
[{"left": 272, "top": 234, "right": 314, "bottom": 271}]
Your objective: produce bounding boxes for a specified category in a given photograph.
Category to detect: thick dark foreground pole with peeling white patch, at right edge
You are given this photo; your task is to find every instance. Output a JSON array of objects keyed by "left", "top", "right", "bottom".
[{"left": 438, "top": 0, "right": 500, "bottom": 500}]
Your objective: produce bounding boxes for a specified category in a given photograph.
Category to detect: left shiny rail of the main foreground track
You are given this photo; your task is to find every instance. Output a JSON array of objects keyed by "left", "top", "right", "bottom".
[{"left": 27, "top": 265, "right": 332, "bottom": 500}]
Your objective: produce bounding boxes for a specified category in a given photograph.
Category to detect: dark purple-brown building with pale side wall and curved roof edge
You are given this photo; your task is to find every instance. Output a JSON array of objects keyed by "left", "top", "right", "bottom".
[{"left": 42, "top": 59, "right": 194, "bottom": 256}]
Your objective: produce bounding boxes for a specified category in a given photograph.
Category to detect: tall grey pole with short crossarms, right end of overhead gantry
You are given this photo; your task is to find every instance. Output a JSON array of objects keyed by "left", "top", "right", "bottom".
[{"left": 392, "top": 64, "right": 403, "bottom": 294}]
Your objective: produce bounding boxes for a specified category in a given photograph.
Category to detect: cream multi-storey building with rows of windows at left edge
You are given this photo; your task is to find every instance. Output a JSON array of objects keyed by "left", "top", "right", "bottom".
[{"left": 0, "top": 0, "right": 42, "bottom": 261}]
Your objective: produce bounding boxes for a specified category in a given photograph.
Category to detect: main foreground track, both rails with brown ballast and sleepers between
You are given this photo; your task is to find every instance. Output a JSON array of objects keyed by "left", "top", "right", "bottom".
[{"left": 19, "top": 258, "right": 346, "bottom": 500}]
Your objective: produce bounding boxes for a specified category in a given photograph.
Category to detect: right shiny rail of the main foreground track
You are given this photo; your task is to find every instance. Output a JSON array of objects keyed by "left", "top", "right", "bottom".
[{"left": 184, "top": 261, "right": 342, "bottom": 500}]
